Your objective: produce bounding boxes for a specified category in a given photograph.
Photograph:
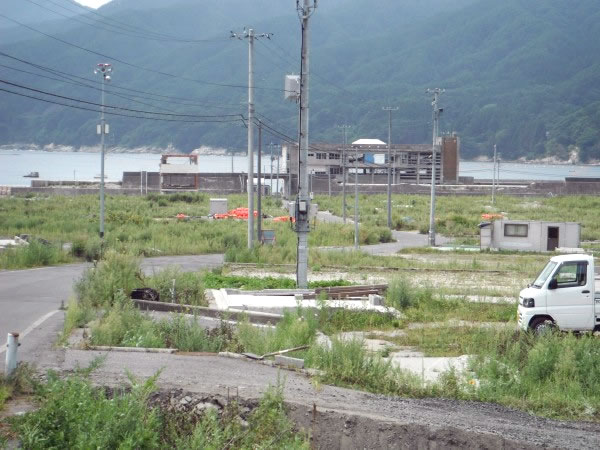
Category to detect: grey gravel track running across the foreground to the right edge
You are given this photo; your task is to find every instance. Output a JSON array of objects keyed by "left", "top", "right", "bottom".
[{"left": 45, "top": 350, "right": 600, "bottom": 449}]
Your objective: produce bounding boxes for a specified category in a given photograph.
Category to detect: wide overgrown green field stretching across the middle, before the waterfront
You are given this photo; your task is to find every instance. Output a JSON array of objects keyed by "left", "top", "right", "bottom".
[{"left": 0, "top": 193, "right": 600, "bottom": 268}]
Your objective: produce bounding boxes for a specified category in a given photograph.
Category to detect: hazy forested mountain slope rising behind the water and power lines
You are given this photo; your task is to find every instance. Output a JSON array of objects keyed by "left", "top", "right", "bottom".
[{"left": 0, "top": 0, "right": 600, "bottom": 160}]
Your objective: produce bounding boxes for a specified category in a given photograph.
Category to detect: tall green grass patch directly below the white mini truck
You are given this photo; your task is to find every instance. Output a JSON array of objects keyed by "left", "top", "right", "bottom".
[{"left": 472, "top": 331, "right": 600, "bottom": 421}]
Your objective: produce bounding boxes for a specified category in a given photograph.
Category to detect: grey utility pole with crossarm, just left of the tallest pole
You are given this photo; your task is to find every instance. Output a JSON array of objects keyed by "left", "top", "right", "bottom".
[{"left": 231, "top": 28, "right": 272, "bottom": 249}]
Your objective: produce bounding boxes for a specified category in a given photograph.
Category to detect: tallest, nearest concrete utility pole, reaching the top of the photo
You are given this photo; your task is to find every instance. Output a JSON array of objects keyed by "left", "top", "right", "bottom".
[{"left": 296, "top": 0, "right": 317, "bottom": 289}]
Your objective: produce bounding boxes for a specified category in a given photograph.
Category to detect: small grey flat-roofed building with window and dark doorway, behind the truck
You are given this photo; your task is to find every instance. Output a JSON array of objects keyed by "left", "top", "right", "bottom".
[{"left": 479, "top": 219, "right": 581, "bottom": 252}]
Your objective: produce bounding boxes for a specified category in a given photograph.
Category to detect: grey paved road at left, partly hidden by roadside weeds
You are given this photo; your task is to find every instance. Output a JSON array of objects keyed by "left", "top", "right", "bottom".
[{"left": 0, "top": 255, "right": 223, "bottom": 353}]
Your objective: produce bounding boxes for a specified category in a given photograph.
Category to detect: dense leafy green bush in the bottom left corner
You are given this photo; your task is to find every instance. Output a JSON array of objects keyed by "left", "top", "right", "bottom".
[{"left": 14, "top": 373, "right": 161, "bottom": 449}]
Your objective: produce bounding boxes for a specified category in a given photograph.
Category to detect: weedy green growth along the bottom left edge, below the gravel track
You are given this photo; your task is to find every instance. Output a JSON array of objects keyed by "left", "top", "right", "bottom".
[{"left": 12, "top": 373, "right": 310, "bottom": 449}]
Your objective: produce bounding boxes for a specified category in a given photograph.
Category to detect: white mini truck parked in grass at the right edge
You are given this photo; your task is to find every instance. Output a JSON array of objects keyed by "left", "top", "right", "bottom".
[{"left": 518, "top": 254, "right": 600, "bottom": 333}]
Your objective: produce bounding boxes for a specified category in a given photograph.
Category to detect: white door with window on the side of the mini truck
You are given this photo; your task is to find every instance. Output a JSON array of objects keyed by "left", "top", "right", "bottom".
[{"left": 546, "top": 261, "right": 594, "bottom": 330}]
